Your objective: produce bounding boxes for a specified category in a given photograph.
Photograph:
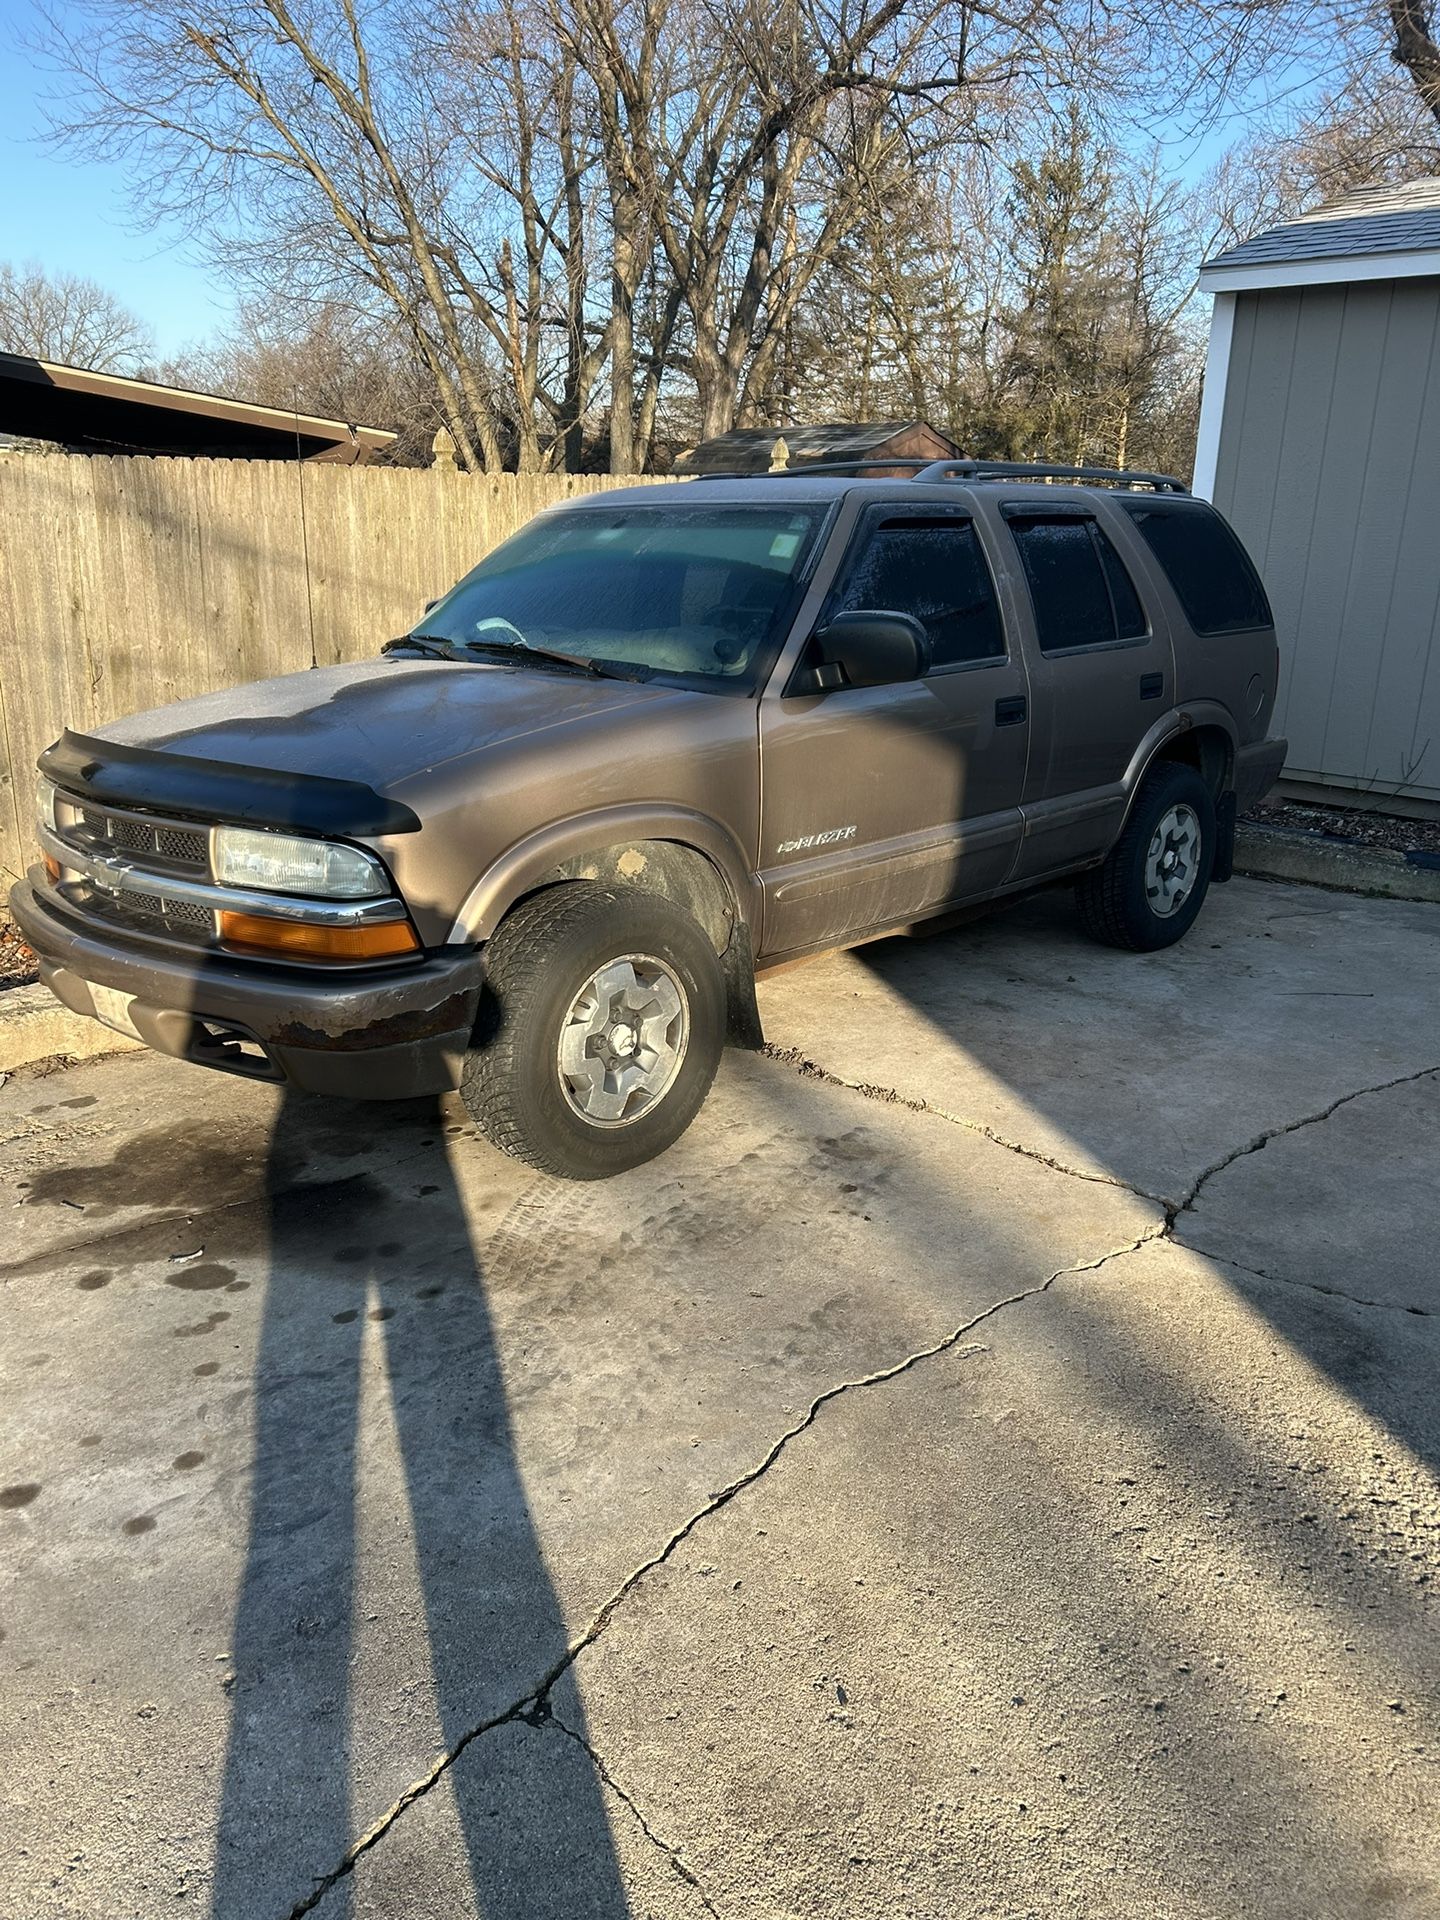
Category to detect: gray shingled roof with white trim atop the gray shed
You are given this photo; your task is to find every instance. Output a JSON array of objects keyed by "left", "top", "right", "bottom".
[{"left": 1200, "top": 177, "right": 1440, "bottom": 292}]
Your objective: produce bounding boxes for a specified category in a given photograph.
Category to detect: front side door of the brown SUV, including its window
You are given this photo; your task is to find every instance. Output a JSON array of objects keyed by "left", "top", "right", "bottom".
[{"left": 758, "top": 501, "right": 1029, "bottom": 958}]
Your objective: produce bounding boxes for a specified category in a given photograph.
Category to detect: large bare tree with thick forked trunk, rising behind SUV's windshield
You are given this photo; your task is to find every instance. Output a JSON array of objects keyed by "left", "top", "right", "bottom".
[{"left": 563, "top": 0, "right": 1105, "bottom": 436}]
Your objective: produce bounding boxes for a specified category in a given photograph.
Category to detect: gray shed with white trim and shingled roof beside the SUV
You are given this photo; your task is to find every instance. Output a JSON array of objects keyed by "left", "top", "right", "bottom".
[{"left": 1194, "top": 179, "right": 1440, "bottom": 812}]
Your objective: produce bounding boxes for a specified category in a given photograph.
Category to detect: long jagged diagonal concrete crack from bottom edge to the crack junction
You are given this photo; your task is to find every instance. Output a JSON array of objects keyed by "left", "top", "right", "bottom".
[{"left": 286, "top": 1219, "right": 1165, "bottom": 1920}]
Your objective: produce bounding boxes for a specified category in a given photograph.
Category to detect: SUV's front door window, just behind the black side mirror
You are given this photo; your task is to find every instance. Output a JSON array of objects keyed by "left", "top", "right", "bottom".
[{"left": 829, "top": 518, "right": 1004, "bottom": 668}]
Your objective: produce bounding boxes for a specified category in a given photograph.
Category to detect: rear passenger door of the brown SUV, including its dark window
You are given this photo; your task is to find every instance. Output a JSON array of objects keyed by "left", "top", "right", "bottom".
[{"left": 1000, "top": 501, "right": 1175, "bottom": 879}]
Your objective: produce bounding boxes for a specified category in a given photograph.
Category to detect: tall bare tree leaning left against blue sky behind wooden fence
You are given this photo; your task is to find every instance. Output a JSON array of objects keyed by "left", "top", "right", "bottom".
[{"left": 35, "top": 0, "right": 568, "bottom": 468}]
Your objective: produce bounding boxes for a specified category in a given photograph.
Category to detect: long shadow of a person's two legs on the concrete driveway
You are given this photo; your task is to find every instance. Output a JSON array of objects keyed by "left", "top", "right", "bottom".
[{"left": 211, "top": 1096, "right": 628, "bottom": 1920}]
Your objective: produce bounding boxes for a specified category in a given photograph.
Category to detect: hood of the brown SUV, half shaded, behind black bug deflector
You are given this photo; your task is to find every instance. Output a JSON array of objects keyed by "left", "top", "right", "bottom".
[{"left": 92, "top": 659, "right": 685, "bottom": 793}]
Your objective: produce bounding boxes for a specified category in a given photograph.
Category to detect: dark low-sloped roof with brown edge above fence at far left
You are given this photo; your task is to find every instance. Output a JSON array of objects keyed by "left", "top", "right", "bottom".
[{"left": 0, "top": 353, "right": 396, "bottom": 467}]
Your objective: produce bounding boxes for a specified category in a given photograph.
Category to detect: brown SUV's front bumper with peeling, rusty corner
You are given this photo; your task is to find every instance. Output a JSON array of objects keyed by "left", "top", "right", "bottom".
[{"left": 10, "top": 870, "right": 484, "bottom": 1100}]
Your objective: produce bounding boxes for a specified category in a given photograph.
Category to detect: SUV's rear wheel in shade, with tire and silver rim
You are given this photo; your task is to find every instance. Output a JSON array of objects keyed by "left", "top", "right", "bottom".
[{"left": 1075, "top": 764, "right": 1215, "bottom": 952}]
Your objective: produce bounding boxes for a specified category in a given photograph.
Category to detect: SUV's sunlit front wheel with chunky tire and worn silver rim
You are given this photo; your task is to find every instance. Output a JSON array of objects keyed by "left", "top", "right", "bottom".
[{"left": 461, "top": 883, "right": 726, "bottom": 1181}]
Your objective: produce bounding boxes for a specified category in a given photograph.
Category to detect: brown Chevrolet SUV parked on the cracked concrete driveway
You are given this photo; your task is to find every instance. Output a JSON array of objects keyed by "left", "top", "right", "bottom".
[{"left": 12, "top": 461, "right": 1284, "bottom": 1179}]
